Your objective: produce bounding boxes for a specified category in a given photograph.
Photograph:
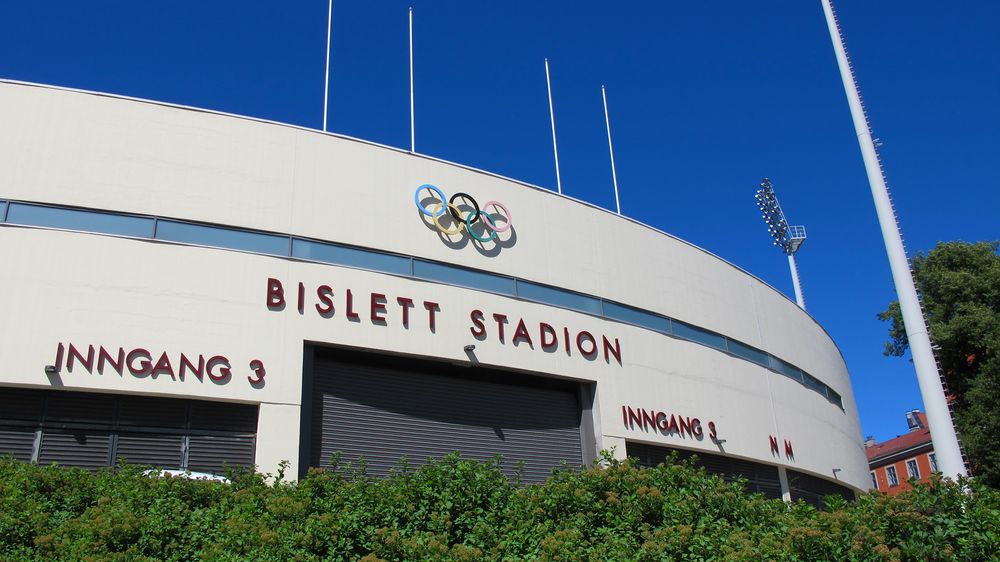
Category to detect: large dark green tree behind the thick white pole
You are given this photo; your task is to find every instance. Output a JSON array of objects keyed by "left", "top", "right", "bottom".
[{"left": 878, "top": 241, "right": 1000, "bottom": 488}]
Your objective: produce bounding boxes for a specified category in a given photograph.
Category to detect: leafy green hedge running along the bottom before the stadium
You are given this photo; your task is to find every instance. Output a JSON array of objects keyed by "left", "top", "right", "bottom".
[{"left": 0, "top": 455, "right": 1000, "bottom": 561}]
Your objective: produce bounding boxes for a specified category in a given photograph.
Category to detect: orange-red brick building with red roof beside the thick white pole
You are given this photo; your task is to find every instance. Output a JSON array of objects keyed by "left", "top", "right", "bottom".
[{"left": 865, "top": 410, "right": 938, "bottom": 496}]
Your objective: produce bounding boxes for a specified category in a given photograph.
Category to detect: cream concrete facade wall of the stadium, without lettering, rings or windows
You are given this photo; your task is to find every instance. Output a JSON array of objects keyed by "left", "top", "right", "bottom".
[{"left": 0, "top": 82, "right": 869, "bottom": 489}]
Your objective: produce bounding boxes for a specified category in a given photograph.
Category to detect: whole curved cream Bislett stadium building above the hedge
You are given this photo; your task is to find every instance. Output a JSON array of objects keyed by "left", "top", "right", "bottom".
[{"left": 0, "top": 81, "right": 869, "bottom": 501}]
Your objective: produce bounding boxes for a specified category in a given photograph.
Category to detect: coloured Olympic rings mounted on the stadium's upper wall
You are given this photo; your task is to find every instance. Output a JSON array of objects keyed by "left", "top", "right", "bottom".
[{"left": 413, "top": 183, "right": 513, "bottom": 238}]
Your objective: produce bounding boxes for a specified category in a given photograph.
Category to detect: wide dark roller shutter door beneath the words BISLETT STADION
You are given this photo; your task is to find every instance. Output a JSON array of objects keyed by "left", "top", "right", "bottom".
[{"left": 310, "top": 360, "right": 582, "bottom": 482}]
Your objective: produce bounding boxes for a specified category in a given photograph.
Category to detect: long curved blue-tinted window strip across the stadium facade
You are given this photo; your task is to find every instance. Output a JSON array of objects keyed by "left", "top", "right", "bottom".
[{"left": 0, "top": 200, "right": 844, "bottom": 410}]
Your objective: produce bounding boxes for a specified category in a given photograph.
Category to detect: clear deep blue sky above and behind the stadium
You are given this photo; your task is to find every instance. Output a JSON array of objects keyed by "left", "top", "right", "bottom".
[{"left": 0, "top": 0, "right": 1000, "bottom": 440}]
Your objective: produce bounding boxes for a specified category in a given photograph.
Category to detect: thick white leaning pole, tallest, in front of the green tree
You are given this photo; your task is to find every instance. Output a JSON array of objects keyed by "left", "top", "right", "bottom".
[{"left": 821, "top": 0, "right": 966, "bottom": 478}]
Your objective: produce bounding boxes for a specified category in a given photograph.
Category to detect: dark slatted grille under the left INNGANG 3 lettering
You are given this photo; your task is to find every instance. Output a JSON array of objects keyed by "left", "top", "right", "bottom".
[{"left": 0, "top": 388, "right": 257, "bottom": 472}]
